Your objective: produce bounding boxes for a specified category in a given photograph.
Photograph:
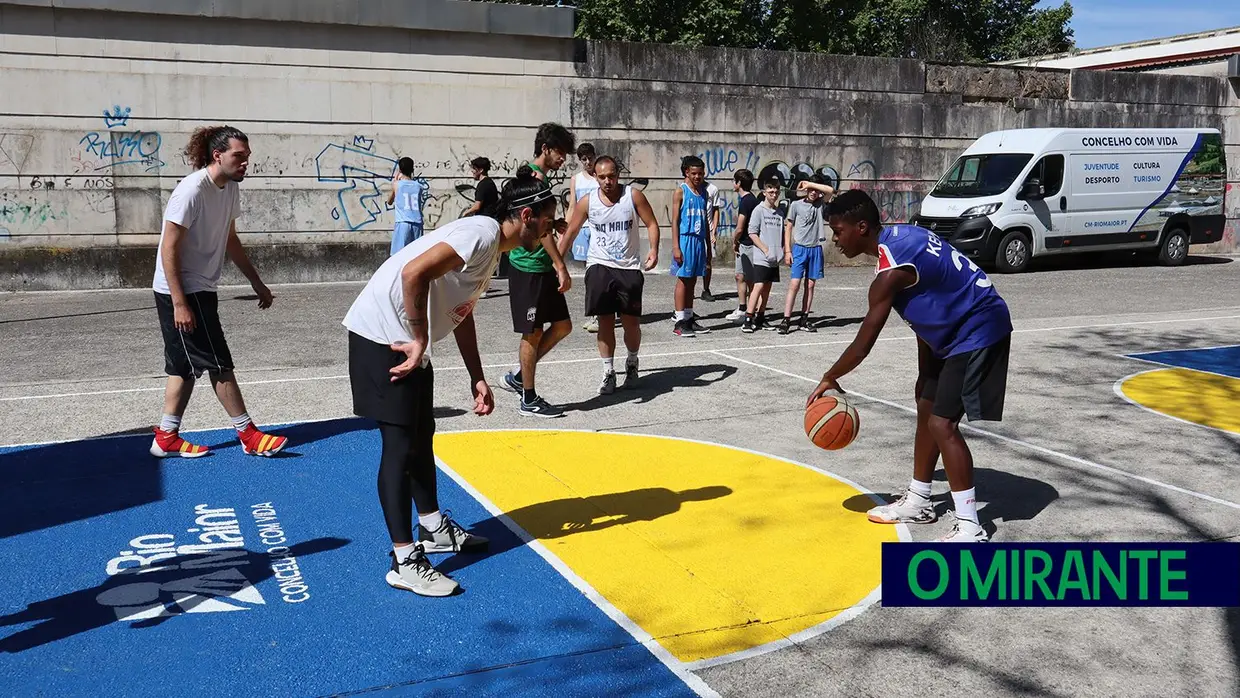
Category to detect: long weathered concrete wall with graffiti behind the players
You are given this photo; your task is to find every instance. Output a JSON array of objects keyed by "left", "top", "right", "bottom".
[{"left": 0, "top": 0, "right": 1240, "bottom": 289}]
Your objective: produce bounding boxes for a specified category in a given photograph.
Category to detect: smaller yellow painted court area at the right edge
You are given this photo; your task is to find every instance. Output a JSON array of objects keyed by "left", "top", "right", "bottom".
[{"left": 1120, "top": 368, "right": 1240, "bottom": 434}]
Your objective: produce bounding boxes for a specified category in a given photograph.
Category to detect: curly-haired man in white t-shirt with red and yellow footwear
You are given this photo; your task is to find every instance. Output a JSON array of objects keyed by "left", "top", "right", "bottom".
[{"left": 150, "top": 126, "right": 288, "bottom": 457}]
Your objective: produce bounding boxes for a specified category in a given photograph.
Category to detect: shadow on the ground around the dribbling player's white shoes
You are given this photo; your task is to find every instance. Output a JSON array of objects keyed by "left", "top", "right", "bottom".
[{"left": 844, "top": 466, "right": 1059, "bottom": 524}]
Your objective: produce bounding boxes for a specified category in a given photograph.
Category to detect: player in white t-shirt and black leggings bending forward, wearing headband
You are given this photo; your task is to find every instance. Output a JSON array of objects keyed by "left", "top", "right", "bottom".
[{"left": 343, "top": 166, "right": 556, "bottom": 596}]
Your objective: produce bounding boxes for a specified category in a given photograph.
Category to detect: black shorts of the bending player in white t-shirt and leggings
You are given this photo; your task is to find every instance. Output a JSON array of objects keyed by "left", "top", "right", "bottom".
[{"left": 348, "top": 332, "right": 435, "bottom": 429}]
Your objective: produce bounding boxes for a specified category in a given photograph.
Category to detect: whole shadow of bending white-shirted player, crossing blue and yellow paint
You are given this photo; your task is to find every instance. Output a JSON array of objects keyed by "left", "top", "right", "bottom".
[{"left": 436, "top": 485, "right": 732, "bottom": 573}]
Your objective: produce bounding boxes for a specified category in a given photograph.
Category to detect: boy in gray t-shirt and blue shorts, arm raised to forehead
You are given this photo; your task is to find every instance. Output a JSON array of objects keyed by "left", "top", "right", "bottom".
[{"left": 779, "top": 175, "right": 835, "bottom": 335}]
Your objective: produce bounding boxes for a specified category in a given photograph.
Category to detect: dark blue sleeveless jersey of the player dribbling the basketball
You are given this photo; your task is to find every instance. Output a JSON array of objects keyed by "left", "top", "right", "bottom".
[{"left": 874, "top": 226, "right": 1012, "bottom": 357}]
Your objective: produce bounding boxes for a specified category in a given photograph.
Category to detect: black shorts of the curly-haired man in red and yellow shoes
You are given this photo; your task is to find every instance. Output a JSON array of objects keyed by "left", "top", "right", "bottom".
[{"left": 155, "top": 291, "right": 233, "bottom": 379}]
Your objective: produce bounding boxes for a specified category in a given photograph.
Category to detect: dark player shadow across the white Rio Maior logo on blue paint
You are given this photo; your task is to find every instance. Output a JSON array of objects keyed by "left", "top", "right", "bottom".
[{"left": 0, "top": 538, "right": 350, "bottom": 652}]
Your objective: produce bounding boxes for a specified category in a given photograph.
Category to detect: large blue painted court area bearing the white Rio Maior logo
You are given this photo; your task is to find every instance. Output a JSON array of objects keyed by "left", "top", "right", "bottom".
[{"left": 0, "top": 419, "right": 693, "bottom": 696}]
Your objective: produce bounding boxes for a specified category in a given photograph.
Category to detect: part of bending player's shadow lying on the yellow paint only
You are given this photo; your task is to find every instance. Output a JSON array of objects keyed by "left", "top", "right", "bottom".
[{"left": 507, "top": 485, "right": 732, "bottom": 541}]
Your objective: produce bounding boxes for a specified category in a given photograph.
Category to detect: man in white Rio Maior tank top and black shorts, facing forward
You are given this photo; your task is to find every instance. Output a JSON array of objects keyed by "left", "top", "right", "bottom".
[{"left": 559, "top": 155, "right": 658, "bottom": 395}]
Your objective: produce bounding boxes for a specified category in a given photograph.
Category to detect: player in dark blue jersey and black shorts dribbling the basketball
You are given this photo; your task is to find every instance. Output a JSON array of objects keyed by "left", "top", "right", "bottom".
[{"left": 801, "top": 188, "right": 1012, "bottom": 543}]
